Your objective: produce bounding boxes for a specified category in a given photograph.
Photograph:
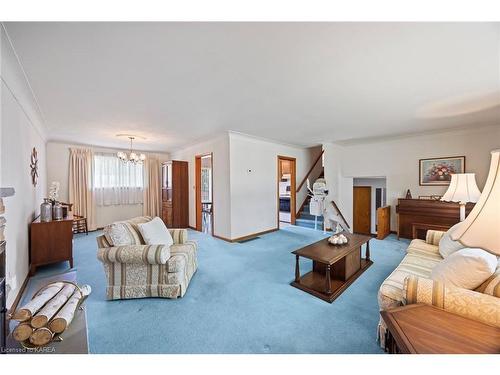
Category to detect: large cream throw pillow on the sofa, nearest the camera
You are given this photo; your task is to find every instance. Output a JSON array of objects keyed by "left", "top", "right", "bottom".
[{"left": 431, "top": 247, "right": 498, "bottom": 290}]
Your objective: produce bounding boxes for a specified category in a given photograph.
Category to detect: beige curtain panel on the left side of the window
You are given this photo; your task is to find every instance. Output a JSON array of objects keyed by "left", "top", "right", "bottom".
[{"left": 69, "top": 148, "right": 96, "bottom": 230}]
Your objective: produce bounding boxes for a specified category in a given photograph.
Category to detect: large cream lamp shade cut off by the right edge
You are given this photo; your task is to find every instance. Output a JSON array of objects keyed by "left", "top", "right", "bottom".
[{"left": 450, "top": 149, "right": 500, "bottom": 255}]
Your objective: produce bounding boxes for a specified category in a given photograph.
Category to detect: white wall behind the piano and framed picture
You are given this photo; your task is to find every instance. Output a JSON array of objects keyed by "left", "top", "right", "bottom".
[{"left": 324, "top": 126, "right": 500, "bottom": 230}]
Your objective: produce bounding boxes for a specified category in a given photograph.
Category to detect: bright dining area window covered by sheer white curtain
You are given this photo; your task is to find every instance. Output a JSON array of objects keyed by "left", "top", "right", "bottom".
[{"left": 92, "top": 153, "right": 144, "bottom": 206}]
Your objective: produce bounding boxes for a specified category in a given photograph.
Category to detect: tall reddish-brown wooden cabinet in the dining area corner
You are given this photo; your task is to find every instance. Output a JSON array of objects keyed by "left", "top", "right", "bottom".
[{"left": 161, "top": 160, "right": 189, "bottom": 228}]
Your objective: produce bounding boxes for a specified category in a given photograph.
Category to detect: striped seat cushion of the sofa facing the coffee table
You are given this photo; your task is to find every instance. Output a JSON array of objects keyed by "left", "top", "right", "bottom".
[{"left": 378, "top": 253, "right": 442, "bottom": 310}]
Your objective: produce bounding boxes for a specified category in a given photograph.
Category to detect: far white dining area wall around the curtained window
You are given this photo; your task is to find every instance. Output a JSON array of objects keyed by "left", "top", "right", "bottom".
[{"left": 47, "top": 142, "right": 169, "bottom": 228}]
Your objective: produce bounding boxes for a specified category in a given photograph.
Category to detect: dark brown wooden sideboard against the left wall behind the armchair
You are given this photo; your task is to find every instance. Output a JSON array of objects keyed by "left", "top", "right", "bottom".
[{"left": 30, "top": 215, "right": 73, "bottom": 276}]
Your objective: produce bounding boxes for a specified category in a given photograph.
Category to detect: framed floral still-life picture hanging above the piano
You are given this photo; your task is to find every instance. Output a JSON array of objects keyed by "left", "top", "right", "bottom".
[{"left": 419, "top": 156, "right": 465, "bottom": 186}]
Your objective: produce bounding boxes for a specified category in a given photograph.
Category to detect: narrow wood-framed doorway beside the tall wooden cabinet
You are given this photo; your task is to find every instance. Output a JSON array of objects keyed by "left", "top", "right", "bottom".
[{"left": 195, "top": 153, "right": 214, "bottom": 235}]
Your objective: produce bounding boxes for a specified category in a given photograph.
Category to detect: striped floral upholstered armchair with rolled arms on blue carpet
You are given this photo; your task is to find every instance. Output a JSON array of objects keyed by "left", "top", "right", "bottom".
[{"left": 97, "top": 216, "right": 197, "bottom": 300}]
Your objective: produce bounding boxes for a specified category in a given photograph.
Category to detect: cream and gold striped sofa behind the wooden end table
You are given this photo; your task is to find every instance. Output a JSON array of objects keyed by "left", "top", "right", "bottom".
[{"left": 378, "top": 230, "right": 500, "bottom": 347}]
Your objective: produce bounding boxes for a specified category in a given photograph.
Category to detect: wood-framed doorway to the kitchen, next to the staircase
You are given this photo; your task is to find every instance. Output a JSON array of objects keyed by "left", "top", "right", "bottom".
[{"left": 277, "top": 156, "right": 296, "bottom": 228}]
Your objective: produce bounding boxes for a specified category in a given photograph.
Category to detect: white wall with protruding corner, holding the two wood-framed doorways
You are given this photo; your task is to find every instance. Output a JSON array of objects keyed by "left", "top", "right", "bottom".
[{"left": 172, "top": 132, "right": 321, "bottom": 239}]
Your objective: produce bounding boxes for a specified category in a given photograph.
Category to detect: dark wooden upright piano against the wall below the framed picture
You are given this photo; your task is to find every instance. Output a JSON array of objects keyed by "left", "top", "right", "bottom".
[{"left": 396, "top": 198, "right": 474, "bottom": 238}]
